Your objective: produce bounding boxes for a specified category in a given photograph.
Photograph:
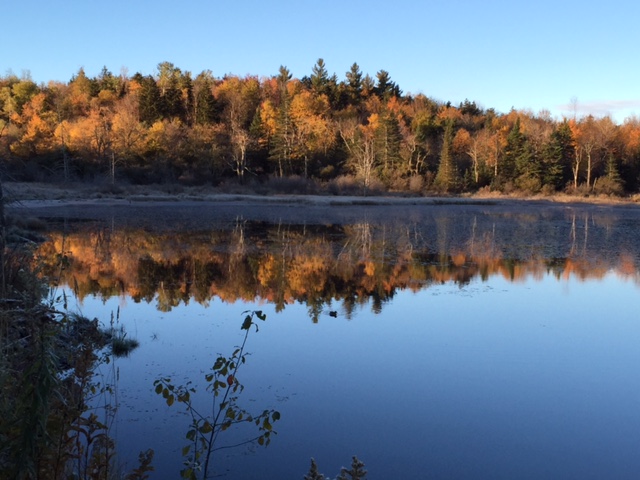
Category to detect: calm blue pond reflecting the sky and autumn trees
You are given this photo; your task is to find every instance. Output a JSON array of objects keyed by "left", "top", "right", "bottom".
[{"left": 17, "top": 202, "right": 640, "bottom": 479}]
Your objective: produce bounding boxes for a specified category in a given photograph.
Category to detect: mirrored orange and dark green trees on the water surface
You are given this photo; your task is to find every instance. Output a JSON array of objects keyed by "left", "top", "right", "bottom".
[{"left": 33, "top": 213, "right": 640, "bottom": 320}]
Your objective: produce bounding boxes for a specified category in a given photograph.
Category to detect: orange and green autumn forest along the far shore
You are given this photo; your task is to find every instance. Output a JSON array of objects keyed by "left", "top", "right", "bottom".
[{"left": 0, "top": 59, "right": 640, "bottom": 195}]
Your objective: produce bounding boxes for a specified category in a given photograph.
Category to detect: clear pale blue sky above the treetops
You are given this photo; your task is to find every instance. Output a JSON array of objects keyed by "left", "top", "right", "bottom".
[{"left": 5, "top": 0, "right": 640, "bottom": 122}]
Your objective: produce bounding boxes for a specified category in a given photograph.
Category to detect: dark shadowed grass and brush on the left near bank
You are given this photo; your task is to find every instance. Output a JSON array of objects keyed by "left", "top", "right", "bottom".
[{"left": 0, "top": 201, "right": 153, "bottom": 480}]
